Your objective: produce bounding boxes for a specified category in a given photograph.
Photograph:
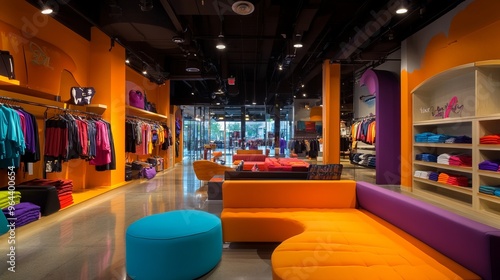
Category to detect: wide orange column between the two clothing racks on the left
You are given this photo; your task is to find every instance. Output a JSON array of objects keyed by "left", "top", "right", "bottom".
[{"left": 86, "top": 28, "right": 125, "bottom": 187}]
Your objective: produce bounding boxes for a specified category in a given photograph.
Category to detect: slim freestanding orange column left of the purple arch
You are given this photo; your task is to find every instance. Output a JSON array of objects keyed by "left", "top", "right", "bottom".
[{"left": 323, "top": 60, "right": 340, "bottom": 164}]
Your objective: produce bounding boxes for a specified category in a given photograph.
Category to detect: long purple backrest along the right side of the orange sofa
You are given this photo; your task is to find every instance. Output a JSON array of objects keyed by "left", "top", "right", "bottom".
[{"left": 356, "top": 182, "right": 500, "bottom": 280}]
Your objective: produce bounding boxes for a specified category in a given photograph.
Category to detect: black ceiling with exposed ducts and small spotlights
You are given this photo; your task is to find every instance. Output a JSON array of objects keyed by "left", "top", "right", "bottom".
[{"left": 28, "top": 0, "right": 463, "bottom": 110}]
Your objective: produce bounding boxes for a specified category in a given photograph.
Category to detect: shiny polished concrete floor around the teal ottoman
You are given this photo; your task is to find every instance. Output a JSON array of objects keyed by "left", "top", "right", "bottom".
[{"left": 0, "top": 161, "right": 496, "bottom": 280}]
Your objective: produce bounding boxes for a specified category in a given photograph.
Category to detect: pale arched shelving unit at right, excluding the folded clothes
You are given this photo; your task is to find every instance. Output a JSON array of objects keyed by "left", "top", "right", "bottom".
[{"left": 412, "top": 60, "right": 500, "bottom": 218}]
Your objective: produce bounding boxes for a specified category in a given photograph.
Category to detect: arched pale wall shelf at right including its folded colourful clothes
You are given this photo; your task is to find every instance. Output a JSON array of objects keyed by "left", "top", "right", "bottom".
[{"left": 412, "top": 60, "right": 500, "bottom": 218}]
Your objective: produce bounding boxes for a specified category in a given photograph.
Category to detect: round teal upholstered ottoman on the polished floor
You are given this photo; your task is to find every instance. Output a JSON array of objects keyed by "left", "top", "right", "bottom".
[{"left": 125, "top": 210, "right": 222, "bottom": 280}]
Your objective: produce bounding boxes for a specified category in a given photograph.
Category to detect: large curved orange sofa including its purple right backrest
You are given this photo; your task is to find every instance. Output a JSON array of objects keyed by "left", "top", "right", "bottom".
[{"left": 221, "top": 180, "right": 500, "bottom": 279}]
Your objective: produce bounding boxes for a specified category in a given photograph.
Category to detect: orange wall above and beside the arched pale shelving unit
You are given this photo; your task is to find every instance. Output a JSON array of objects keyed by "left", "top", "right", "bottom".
[{"left": 401, "top": 0, "right": 500, "bottom": 186}]
